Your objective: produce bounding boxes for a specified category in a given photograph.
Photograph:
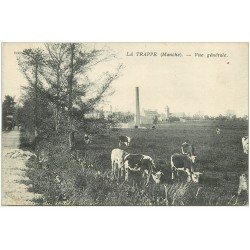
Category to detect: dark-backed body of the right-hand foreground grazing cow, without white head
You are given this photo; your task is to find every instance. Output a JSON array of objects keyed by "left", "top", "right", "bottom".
[{"left": 171, "top": 153, "right": 194, "bottom": 182}]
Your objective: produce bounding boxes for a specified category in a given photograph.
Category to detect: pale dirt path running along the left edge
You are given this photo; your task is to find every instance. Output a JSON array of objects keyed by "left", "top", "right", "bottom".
[{"left": 2, "top": 131, "right": 38, "bottom": 206}]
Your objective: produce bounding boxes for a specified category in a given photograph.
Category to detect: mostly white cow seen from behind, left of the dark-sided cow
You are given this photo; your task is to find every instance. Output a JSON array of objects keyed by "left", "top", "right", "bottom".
[{"left": 111, "top": 148, "right": 128, "bottom": 182}]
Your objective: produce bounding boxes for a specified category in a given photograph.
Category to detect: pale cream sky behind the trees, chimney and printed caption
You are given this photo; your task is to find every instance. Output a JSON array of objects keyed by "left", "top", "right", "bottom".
[{"left": 2, "top": 43, "right": 248, "bottom": 116}]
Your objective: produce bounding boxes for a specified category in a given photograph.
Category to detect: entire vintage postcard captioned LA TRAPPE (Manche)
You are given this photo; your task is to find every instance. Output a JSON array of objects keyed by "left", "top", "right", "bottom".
[{"left": 1, "top": 43, "right": 249, "bottom": 206}]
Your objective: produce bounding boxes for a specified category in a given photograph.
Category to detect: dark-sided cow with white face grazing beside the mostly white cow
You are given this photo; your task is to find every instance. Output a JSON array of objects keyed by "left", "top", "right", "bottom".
[{"left": 124, "top": 154, "right": 161, "bottom": 186}]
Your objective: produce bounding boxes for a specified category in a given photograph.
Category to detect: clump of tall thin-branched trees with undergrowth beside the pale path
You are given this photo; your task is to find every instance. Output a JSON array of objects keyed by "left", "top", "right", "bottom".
[{"left": 5, "top": 43, "right": 123, "bottom": 149}]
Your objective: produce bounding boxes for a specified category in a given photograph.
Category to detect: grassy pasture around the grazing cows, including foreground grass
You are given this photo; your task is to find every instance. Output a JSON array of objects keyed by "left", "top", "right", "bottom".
[{"left": 23, "top": 121, "right": 248, "bottom": 205}]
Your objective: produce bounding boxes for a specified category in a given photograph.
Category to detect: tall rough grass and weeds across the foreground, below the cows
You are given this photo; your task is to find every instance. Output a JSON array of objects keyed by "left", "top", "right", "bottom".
[{"left": 23, "top": 147, "right": 247, "bottom": 206}]
